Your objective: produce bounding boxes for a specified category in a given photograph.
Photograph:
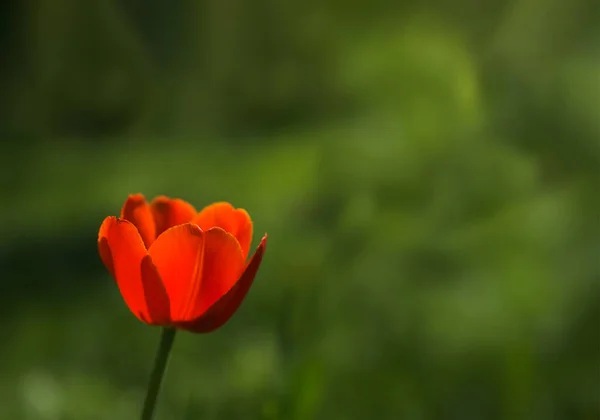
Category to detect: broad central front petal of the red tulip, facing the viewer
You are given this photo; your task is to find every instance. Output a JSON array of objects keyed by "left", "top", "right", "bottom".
[{"left": 149, "top": 223, "right": 244, "bottom": 322}]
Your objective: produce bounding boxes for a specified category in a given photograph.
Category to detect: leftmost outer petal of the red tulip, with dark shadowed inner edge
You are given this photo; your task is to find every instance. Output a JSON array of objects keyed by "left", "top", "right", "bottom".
[{"left": 101, "top": 217, "right": 170, "bottom": 325}]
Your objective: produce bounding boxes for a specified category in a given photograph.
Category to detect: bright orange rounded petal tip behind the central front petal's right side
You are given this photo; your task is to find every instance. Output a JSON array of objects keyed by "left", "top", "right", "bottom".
[{"left": 192, "top": 202, "right": 252, "bottom": 260}]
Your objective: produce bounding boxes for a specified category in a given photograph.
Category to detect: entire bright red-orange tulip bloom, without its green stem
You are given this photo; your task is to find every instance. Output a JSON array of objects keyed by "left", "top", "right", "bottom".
[{"left": 98, "top": 194, "right": 267, "bottom": 333}]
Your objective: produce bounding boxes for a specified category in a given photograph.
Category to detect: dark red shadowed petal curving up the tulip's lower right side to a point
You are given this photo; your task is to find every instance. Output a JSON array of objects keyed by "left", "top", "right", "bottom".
[{"left": 178, "top": 234, "right": 267, "bottom": 333}]
